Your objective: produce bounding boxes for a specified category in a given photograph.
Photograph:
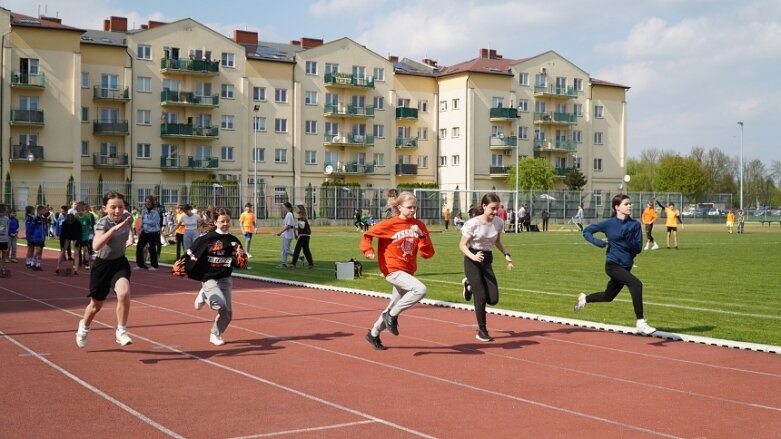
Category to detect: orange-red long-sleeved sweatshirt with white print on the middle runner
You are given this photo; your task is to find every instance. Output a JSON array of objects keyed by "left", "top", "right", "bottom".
[{"left": 360, "top": 216, "right": 434, "bottom": 276}]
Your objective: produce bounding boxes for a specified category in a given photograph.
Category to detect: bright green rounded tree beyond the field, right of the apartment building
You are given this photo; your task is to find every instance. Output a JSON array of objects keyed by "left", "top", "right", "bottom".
[{"left": 654, "top": 155, "right": 710, "bottom": 200}]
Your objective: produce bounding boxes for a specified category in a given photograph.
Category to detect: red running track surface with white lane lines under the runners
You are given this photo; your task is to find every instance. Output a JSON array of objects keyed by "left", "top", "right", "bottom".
[{"left": 0, "top": 253, "right": 781, "bottom": 438}]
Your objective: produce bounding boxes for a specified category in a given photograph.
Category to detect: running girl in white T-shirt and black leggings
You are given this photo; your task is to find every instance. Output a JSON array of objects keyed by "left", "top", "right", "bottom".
[{"left": 458, "top": 193, "right": 513, "bottom": 341}]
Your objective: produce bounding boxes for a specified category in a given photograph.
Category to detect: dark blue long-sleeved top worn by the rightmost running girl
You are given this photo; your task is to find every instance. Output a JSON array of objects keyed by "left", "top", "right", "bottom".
[{"left": 583, "top": 216, "right": 643, "bottom": 269}]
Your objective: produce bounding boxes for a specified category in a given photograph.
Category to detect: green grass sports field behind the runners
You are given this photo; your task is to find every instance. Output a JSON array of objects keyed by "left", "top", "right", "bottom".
[{"left": 149, "top": 224, "right": 781, "bottom": 345}]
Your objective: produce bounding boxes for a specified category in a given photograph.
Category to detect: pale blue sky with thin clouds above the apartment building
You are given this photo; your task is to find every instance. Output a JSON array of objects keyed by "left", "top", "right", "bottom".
[{"left": 6, "top": 0, "right": 781, "bottom": 166}]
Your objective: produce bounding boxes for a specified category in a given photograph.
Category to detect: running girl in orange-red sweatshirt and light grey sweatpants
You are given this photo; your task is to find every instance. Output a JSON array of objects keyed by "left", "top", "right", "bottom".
[{"left": 360, "top": 192, "right": 434, "bottom": 350}]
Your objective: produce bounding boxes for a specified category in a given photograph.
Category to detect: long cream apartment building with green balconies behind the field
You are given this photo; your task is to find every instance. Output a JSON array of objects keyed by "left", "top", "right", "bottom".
[{"left": 0, "top": 9, "right": 628, "bottom": 209}]
